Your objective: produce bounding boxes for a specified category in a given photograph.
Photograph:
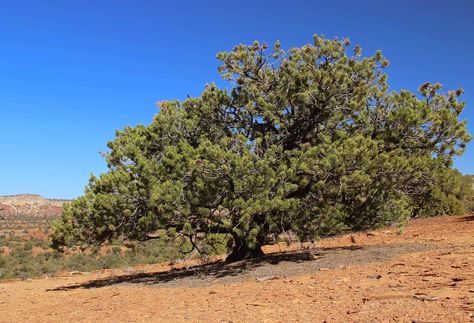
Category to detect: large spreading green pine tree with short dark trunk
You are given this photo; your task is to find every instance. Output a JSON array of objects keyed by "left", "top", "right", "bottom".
[{"left": 53, "top": 35, "right": 470, "bottom": 261}]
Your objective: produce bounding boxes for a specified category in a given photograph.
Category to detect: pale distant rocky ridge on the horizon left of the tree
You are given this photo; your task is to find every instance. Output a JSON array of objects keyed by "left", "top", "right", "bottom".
[{"left": 0, "top": 194, "right": 67, "bottom": 217}]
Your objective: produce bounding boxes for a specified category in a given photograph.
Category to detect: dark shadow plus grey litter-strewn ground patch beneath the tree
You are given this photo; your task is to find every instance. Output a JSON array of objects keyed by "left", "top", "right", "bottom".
[{"left": 48, "top": 243, "right": 440, "bottom": 292}]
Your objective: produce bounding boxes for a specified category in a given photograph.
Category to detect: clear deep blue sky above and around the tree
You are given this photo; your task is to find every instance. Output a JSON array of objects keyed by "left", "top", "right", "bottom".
[{"left": 0, "top": 0, "right": 474, "bottom": 198}]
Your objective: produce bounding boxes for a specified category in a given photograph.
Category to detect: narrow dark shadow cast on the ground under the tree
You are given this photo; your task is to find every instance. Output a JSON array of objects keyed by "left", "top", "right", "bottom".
[{"left": 47, "top": 246, "right": 364, "bottom": 291}]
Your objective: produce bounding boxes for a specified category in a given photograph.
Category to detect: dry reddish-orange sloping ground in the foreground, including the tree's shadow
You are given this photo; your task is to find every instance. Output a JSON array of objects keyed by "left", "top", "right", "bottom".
[{"left": 0, "top": 215, "right": 474, "bottom": 322}]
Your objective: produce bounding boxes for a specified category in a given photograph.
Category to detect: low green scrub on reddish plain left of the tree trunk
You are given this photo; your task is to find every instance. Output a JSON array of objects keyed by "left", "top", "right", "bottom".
[{"left": 0, "top": 216, "right": 225, "bottom": 280}]
